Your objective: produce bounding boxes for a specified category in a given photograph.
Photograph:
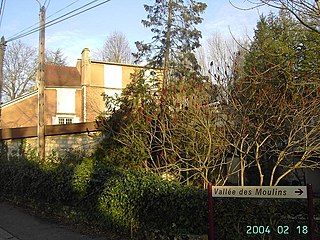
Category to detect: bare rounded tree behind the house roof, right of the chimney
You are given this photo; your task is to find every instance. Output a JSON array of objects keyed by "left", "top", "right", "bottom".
[{"left": 95, "top": 31, "right": 132, "bottom": 63}]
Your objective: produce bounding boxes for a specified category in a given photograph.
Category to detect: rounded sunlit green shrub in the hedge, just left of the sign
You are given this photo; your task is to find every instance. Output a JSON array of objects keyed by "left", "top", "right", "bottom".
[{"left": 99, "top": 171, "right": 208, "bottom": 236}]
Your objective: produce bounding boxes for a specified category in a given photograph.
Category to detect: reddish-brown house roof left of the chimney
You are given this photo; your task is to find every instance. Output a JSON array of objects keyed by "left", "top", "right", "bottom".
[{"left": 44, "top": 64, "right": 81, "bottom": 87}]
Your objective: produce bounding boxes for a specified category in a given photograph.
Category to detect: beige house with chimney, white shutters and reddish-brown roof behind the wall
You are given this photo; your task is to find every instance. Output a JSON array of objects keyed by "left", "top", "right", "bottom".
[{"left": 1, "top": 48, "right": 150, "bottom": 128}]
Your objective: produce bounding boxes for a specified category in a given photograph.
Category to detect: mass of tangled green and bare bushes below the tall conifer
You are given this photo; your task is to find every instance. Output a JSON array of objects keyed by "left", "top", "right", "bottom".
[{"left": 98, "top": 67, "right": 237, "bottom": 186}]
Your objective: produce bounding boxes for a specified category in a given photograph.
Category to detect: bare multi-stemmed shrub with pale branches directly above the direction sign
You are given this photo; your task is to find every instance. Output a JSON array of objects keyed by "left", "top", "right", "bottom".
[{"left": 210, "top": 52, "right": 320, "bottom": 186}]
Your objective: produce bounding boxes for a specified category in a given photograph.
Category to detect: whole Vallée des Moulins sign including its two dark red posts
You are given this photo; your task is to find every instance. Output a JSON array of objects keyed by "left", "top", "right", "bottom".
[{"left": 208, "top": 183, "right": 315, "bottom": 240}]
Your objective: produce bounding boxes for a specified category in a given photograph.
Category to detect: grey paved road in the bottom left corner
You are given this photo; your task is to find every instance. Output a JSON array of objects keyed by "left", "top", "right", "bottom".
[{"left": 0, "top": 202, "right": 106, "bottom": 240}]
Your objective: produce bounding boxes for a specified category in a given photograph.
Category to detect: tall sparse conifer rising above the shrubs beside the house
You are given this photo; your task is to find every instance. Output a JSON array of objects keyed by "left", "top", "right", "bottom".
[{"left": 134, "top": 0, "right": 207, "bottom": 82}]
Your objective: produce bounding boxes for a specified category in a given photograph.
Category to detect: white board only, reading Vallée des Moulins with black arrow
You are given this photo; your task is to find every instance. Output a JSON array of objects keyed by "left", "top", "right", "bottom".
[{"left": 212, "top": 186, "right": 307, "bottom": 198}]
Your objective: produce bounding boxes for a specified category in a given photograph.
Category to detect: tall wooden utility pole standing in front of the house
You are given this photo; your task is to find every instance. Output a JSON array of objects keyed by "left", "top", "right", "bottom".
[{"left": 37, "top": 6, "right": 46, "bottom": 160}]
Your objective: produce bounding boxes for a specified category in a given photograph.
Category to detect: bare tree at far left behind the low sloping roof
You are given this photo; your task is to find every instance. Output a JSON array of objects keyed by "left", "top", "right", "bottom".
[{"left": 3, "top": 41, "right": 37, "bottom": 101}]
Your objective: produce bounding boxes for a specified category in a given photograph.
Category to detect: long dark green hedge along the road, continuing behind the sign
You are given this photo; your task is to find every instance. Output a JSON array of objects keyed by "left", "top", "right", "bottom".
[{"left": 0, "top": 158, "right": 320, "bottom": 240}]
